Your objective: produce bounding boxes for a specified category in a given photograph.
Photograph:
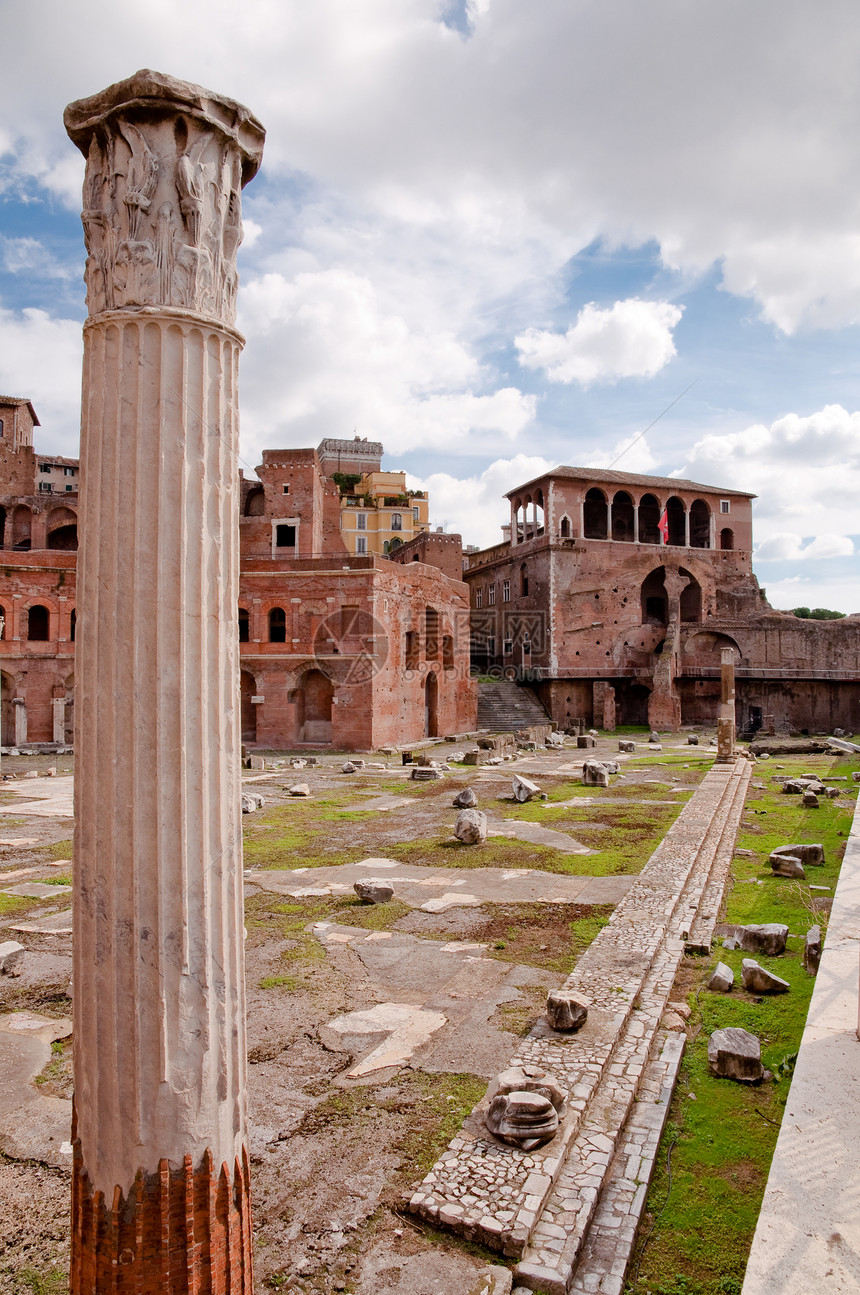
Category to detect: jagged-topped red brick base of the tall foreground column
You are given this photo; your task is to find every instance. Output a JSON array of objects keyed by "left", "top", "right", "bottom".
[{"left": 70, "top": 1108, "right": 254, "bottom": 1295}]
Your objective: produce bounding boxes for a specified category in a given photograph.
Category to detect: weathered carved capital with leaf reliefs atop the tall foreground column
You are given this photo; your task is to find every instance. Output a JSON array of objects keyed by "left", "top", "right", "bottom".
[{"left": 63, "top": 70, "right": 266, "bottom": 324}]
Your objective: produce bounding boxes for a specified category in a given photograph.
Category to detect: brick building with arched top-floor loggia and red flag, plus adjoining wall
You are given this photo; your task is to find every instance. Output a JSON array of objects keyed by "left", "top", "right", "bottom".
[{"left": 464, "top": 467, "right": 860, "bottom": 733}]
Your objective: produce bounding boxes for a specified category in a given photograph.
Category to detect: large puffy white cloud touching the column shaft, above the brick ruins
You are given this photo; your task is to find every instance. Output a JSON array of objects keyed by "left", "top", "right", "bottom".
[{"left": 231, "top": 268, "right": 535, "bottom": 461}]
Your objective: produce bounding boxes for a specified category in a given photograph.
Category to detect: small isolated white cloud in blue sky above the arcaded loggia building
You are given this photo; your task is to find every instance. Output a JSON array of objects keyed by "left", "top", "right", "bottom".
[{"left": 515, "top": 297, "right": 683, "bottom": 387}]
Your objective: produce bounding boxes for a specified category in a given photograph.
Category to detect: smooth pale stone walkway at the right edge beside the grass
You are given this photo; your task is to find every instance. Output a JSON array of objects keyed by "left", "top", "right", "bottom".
[{"left": 743, "top": 777, "right": 860, "bottom": 1295}]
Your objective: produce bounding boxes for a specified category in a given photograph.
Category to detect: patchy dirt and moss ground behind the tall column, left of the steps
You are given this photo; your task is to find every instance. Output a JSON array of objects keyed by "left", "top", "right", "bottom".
[{"left": 0, "top": 737, "right": 712, "bottom": 1295}]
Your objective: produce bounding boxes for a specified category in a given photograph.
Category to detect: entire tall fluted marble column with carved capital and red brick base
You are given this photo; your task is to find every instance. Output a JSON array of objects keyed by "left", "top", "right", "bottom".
[{"left": 65, "top": 71, "right": 264, "bottom": 1295}]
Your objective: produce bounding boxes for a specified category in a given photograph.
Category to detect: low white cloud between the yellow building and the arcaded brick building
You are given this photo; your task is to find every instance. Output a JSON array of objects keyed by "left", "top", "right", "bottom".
[{"left": 418, "top": 455, "right": 556, "bottom": 548}]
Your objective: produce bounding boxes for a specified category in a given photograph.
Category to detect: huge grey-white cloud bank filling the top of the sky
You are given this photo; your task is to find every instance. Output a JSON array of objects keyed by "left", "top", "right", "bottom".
[{"left": 0, "top": 0, "right": 860, "bottom": 329}]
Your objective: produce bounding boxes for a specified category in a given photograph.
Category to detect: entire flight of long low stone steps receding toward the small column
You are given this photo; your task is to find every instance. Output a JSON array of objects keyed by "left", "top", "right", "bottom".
[{"left": 409, "top": 760, "right": 750, "bottom": 1295}]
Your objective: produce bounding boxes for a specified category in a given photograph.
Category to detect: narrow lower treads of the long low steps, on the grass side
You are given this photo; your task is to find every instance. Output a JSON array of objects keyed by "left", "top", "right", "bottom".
[{"left": 517, "top": 761, "right": 750, "bottom": 1295}]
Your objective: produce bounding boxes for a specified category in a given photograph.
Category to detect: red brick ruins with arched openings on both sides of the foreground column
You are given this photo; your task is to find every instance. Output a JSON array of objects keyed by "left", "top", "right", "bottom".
[{"left": 0, "top": 398, "right": 477, "bottom": 750}]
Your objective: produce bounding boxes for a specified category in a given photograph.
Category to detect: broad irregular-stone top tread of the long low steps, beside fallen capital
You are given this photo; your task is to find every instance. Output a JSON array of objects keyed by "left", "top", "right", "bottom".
[{"left": 409, "top": 767, "right": 749, "bottom": 1259}]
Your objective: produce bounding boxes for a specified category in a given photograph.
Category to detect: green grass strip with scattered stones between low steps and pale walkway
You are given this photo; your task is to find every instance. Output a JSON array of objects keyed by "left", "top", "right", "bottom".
[{"left": 628, "top": 755, "right": 860, "bottom": 1295}]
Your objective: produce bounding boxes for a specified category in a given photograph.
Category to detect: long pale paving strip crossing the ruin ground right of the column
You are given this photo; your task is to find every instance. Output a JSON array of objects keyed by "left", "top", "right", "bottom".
[{"left": 245, "top": 865, "right": 636, "bottom": 913}]
